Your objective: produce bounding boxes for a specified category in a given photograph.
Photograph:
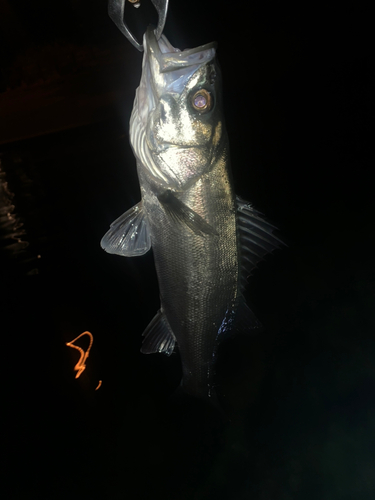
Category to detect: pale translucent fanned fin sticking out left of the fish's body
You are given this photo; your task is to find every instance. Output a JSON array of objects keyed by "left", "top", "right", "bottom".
[{"left": 100, "top": 201, "right": 151, "bottom": 257}]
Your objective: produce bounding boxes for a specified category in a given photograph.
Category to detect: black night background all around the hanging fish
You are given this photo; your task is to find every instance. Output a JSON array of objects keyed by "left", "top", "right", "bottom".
[{"left": 0, "top": 0, "right": 375, "bottom": 500}]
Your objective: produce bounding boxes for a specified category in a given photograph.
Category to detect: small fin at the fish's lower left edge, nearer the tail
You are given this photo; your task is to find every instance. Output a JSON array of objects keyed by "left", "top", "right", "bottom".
[{"left": 141, "top": 310, "right": 176, "bottom": 356}]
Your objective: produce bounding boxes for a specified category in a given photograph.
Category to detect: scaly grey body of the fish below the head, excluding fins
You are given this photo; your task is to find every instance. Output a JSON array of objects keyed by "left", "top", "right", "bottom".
[{"left": 141, "top": 145, "right": 238, "bottom": 397}]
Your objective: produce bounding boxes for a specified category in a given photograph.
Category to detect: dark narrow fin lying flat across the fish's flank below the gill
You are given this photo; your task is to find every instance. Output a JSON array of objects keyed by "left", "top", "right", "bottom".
[{"left": 158, "top": 190, "right": 217, "bottom": 235}]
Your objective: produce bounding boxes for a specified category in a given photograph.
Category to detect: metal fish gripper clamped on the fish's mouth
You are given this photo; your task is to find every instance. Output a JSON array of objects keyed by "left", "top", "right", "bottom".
[{"left": 108, "top": 0, "right": 169, "bottom": 52}]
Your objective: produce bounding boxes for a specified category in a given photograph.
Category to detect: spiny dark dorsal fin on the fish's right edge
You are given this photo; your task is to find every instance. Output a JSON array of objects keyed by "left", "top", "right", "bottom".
[{"left": 236, "top": 196, "right": 285, "bottom": 288}]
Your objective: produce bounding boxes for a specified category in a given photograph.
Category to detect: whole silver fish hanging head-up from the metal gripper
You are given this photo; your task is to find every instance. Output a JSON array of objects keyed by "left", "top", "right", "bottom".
[{"left": 101, "top": 28, "right": 283, "bottom": 401}]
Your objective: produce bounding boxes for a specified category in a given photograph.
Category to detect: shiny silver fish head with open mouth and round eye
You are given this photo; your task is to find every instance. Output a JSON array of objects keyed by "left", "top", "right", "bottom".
[{"left": 132, "top": 29, "right": 224, "bottom": 189}]
